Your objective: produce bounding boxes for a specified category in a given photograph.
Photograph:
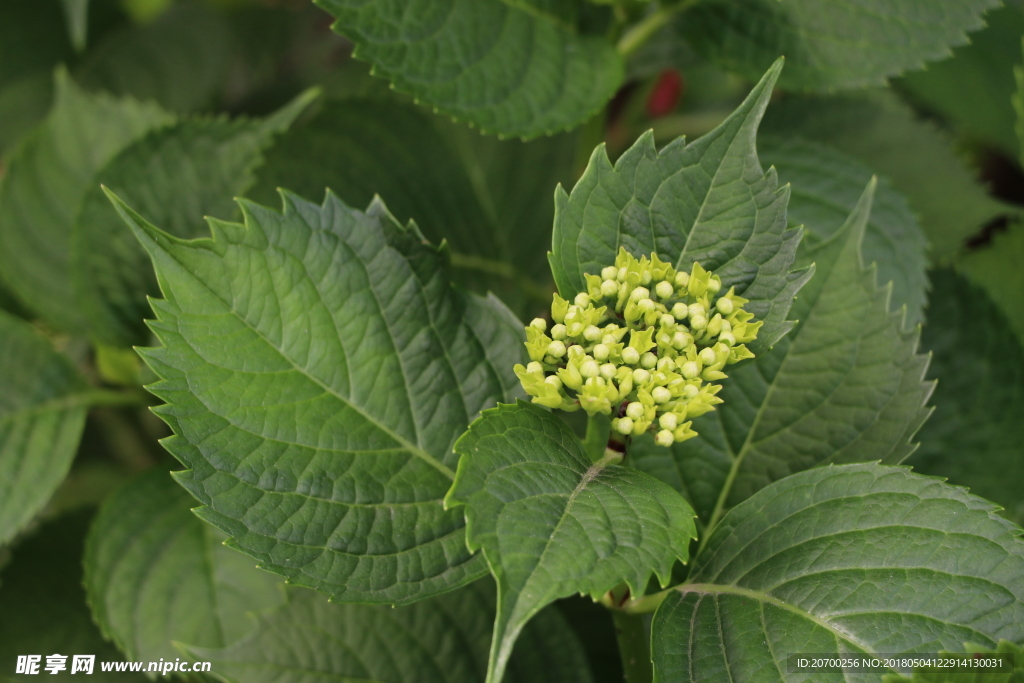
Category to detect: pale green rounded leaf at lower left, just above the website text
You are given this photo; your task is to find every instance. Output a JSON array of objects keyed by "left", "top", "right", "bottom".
[{"left": 85, "top": 468, "right": 285, "bottom": 661}]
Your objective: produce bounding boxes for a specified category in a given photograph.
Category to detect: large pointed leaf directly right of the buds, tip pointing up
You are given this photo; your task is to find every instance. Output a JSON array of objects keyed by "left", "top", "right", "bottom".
[{"left": 632, "top": 183, "right": 933, "bottom": 528}]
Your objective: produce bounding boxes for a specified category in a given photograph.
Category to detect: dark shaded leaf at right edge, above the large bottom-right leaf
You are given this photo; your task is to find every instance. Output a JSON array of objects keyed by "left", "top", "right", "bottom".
[{"left": 910, "top": 269, "right": 1024, "bottom": 523}]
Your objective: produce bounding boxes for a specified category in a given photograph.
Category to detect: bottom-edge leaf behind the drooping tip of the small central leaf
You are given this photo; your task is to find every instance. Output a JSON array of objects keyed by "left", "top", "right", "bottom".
[{"left": 187, "top": 581, "right": 592, "bottom": 683}]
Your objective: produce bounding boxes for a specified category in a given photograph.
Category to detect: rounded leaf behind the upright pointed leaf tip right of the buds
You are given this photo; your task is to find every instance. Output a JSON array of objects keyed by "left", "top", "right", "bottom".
[{"left": 758, "top": 135, "right": 928, "bottom": 326}]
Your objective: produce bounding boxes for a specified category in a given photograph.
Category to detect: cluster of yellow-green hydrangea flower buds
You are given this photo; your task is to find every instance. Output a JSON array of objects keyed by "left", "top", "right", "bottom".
[{"left": 515, "top": 249, "right": 761, "bottom": 445}]
